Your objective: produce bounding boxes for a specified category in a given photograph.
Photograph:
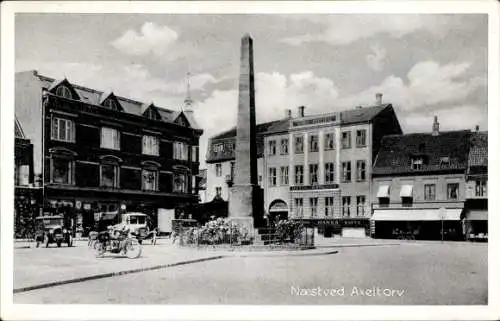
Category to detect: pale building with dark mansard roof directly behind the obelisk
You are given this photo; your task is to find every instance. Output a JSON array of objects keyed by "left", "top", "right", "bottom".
[{"left": 205, "top": 121, "right": 280, "bottom": 202}]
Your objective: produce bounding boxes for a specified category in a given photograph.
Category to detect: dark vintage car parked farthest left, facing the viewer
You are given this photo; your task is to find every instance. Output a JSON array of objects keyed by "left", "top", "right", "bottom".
[{"left": 35, "top": 215, "right": 73, "bottom": 247}]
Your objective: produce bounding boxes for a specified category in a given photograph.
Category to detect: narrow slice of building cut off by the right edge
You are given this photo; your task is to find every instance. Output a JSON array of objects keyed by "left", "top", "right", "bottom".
[{"left": 464, "top": 127, "right": 488, "bottom": 239}]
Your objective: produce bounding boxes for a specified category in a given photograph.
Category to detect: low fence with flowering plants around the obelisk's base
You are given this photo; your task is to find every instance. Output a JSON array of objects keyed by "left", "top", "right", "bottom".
[{"left": 178, "top": 227, "right": 314, "bottom": 248}]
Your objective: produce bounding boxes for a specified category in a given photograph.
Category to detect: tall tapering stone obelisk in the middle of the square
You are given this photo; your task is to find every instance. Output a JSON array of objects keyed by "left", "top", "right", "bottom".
[{"left": 229, "top": 34, "right": 262, "bottom": 231}]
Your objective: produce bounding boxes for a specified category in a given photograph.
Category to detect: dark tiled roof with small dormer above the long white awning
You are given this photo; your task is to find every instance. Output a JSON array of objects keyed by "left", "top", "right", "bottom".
[{"left": 373, "top": 130, "right": 470, "bottom": 175}]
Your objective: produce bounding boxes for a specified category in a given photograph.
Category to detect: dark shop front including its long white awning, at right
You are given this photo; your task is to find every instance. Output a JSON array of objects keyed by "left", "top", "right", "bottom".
[{"left": 371, "top": 208, "right": 463, "bottom": 240}]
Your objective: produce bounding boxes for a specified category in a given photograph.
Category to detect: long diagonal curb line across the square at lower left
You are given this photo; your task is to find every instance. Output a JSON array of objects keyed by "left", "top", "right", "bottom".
[{"left": 13, "top": 255, "right": 226, "bottom": 294}]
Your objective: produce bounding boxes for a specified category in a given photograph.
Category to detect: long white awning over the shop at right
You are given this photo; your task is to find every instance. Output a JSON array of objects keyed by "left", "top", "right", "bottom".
[{"left": 371, "top": 208, "right": 462, "bottom": 221}]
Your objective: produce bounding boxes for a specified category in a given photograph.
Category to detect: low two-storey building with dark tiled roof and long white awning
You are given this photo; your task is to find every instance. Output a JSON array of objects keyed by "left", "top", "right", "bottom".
[{"left": 371, "top": 117, "right": 470, "bottom": 239}]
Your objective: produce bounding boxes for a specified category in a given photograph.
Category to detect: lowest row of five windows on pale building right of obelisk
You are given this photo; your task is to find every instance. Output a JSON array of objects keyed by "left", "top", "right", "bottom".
[{"left": 293, "top": 195, "right": 368, "bottom": 217}]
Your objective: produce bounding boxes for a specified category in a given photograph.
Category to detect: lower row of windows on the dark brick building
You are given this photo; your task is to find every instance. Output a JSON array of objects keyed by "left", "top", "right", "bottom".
[{"left": 50, "top": 157, "right": 189, "bottom": 193}]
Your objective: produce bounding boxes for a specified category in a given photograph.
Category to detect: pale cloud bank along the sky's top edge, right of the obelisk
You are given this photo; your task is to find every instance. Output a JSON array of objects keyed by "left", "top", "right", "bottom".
[{"left": 281, "top": 14, "right": 450, "bottom": 46}]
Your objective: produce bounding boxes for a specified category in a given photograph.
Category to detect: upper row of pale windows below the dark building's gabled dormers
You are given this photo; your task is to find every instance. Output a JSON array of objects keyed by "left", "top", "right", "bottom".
[{"left": 51, "top": 117, "right": 199, "bottom": 162}]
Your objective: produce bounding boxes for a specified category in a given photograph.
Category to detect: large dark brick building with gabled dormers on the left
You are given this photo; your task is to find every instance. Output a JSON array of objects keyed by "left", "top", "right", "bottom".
[{"left": 15, "top": 71, "right": 203, "bottom": 234}]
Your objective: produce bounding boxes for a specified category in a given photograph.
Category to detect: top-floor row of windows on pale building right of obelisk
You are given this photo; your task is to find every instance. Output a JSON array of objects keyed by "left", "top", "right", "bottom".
[{"left": 268, "top": 129, "right": 366, "bottom": 155}]
